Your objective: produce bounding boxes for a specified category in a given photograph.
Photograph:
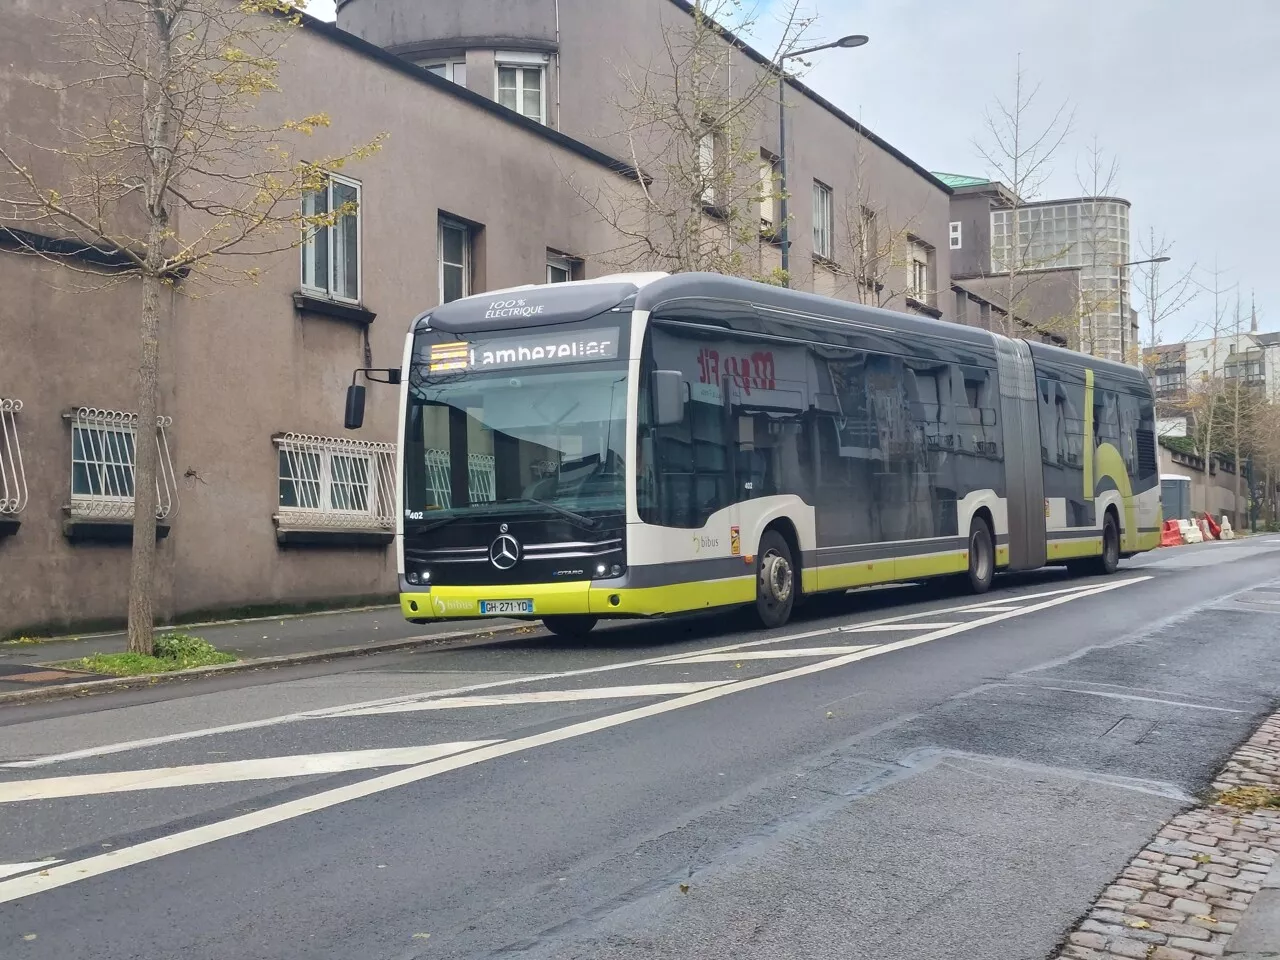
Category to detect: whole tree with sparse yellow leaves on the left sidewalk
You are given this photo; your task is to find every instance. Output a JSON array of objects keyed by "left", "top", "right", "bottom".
[{"left": 0, "top": 0, "right": 379, "bottom": 653}]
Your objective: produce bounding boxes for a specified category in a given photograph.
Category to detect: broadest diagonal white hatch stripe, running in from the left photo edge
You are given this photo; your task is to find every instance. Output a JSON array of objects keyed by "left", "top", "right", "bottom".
[{"left": 0, "top": 740, "right": 502, "bottom": 804}]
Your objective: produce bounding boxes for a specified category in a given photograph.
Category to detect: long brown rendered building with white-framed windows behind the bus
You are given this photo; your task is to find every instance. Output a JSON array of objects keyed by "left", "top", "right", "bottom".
[{"left": 0, "top": 0, "right": 977, "bottom": 636}]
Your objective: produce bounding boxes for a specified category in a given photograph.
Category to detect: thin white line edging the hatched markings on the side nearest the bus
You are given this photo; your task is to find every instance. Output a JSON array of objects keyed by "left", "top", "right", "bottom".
[{"left": 0, "top": 576, "right": 1151, "bottom": 769}]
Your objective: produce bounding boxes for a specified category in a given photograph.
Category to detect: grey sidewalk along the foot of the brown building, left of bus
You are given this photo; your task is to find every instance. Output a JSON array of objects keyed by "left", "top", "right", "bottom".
[{"left": 0, "top": 607, "right": 529, "bottom": 699}]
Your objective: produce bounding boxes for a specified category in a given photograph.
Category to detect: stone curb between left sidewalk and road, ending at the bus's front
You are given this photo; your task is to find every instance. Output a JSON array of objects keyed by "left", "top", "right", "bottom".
[{"left": 0, "top": 623, "right": 530, "bottom": 707}]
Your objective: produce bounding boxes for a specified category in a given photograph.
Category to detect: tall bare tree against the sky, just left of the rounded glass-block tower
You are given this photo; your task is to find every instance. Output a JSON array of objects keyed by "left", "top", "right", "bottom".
[{"left": 974, "top": 54, "right": 1079, "bottom": 334}]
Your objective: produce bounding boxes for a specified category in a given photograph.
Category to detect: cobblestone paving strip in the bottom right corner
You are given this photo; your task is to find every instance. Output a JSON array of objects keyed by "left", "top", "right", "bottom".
[{"left": 1053, "top": 713, "right": 1280, "bottom": 960}]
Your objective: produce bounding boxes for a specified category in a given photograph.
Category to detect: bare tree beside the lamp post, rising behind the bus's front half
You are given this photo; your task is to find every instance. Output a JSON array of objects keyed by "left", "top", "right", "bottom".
[{"left": 577, "top": 0, "right": 812, "bottom": 283}]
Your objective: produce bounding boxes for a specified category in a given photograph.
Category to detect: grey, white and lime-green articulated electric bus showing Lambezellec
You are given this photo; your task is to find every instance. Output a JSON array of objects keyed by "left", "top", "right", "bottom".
[{"left": 347, "top": 274, "right": 1161, "bottom": 635}]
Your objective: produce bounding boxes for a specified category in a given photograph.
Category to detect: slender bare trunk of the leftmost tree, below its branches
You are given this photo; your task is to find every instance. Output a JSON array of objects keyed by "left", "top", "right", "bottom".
[{"left": 129, "top": 273, "right": 164, "bottom": 654}]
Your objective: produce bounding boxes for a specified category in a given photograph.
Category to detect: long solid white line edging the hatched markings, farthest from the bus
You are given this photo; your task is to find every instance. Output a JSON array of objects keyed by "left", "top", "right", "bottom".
[{"left": 0, "top": 576, "right": 1151, "bottom": 904}]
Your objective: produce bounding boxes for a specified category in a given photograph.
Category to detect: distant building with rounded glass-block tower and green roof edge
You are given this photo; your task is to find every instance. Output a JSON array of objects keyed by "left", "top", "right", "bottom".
[{"left": 937, "top": 174, "right": 1139, "bottom": 364}]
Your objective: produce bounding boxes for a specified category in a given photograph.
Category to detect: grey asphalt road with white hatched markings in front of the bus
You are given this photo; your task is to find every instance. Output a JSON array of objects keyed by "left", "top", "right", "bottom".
[{"left": 0, "top": 536, "right": 1280, "bottom": 960}]
